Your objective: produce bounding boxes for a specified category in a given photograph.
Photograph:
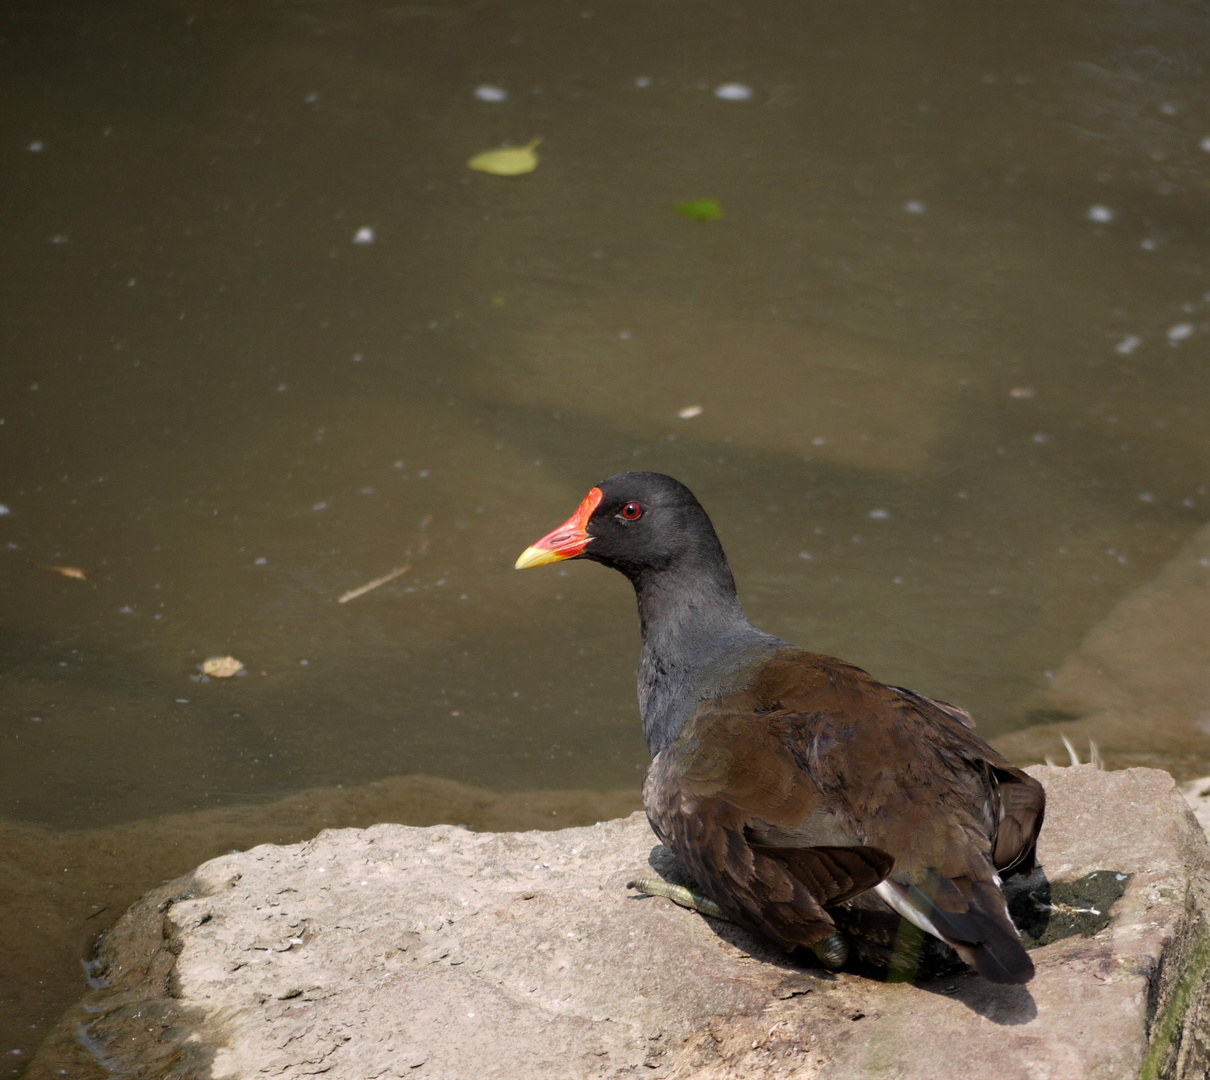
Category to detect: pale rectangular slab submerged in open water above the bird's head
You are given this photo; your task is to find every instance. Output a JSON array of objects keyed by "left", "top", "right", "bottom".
[{"left": 466, "top": 301, "right": 962, "bottom": 475}]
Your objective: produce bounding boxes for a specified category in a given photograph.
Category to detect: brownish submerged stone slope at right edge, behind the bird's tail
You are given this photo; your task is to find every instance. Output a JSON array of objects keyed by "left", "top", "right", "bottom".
[{"left": 996, "top": 525, "right": 1210, "bottom": 779}]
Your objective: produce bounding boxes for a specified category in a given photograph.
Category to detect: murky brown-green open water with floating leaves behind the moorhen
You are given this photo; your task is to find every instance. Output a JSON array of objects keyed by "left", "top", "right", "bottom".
[{"left": 0, "top": 0, "right": 1210, "bottom": 1064}]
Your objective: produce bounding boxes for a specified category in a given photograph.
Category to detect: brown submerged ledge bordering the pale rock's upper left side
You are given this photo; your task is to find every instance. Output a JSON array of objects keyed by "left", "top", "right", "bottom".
[{"left": 0, "top": 776, "right": 643, "bottom": 1063}]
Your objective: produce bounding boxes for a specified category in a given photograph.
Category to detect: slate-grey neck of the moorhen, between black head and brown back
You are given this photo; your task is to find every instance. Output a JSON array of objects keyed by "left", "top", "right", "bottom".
[{"left": 632, "top": 560, "right": 787, "bottom": 757}]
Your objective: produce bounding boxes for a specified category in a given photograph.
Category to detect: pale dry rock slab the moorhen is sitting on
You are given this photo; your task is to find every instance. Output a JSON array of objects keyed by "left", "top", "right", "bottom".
[{"left": 28, "top": 766, "right": 1210, "bottom": 1080}]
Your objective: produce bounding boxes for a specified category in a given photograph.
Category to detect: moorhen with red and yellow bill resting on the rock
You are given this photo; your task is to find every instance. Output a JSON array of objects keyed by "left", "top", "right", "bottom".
[{"left": 517, "top": 473, "right": 1045, "bottom": 983}]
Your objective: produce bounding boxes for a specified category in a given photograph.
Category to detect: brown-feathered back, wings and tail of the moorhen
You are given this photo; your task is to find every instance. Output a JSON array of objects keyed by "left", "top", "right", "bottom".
[{"left": 644, "top": 649, "right": 1045, "bottom": 982}]
